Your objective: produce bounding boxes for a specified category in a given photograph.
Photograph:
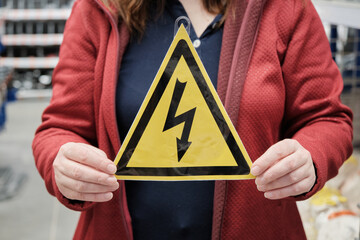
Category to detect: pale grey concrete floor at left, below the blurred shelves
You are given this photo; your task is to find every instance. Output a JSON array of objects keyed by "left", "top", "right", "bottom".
[{"left": 0, "top": 99, "right": 79, "bottom": 240}]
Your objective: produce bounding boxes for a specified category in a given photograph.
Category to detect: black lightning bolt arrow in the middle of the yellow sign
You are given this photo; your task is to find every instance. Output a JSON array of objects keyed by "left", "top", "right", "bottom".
[{"left": 163, "top": 79, "right": 196, "bottom": 162}]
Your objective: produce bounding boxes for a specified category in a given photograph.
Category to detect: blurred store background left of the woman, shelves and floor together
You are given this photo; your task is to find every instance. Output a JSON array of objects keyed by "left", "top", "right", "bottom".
[{"left": 0, "top": 0, "right": 79, "bottom": 240}]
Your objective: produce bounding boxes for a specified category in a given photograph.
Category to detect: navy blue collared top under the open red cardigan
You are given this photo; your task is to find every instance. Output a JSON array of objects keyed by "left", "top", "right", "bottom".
[{"left": 116, "top": 0, "right": 223, "bottom": 240}]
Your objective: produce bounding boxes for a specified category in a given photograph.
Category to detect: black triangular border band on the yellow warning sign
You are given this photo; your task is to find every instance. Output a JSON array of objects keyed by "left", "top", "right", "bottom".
[{"left": 115, "top": 39, "right": 250, "bottom": 177}]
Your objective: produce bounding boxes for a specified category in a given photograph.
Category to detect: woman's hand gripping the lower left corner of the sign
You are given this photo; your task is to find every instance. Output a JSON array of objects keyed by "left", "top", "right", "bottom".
[{"left": 53, "top": 143, "right": 119, "bottom": 202}]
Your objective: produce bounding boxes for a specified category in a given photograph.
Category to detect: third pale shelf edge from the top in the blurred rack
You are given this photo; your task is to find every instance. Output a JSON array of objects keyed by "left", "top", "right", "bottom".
[{"left": 0, "top": 57, "right": 59, "bottom": 69}]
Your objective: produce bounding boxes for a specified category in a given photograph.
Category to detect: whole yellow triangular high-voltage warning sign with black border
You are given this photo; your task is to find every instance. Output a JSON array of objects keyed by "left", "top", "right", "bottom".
[{"left": 115, "top": 25, "right": 254, "bottom": 181}]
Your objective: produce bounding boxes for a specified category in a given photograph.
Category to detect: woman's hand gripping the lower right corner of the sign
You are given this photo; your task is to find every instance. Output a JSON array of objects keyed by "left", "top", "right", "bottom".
[{"left": 251, "top": 139, "right": 316, "bottom": 199}]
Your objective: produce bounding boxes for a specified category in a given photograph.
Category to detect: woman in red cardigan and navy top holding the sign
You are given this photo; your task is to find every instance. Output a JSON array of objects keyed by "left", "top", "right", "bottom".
[{"left": 33, "top": 0, "right": 352, "bottom": 239}]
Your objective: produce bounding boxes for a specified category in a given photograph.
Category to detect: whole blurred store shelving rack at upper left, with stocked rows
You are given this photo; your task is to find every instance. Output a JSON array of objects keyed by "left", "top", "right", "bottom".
[{"left": 0, "top": 0, "right": 74, "bottom": 92}]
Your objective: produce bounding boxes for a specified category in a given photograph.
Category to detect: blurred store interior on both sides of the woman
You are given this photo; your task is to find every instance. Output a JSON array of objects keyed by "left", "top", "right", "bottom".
[{"left": 0, "top": 0, "right": 360, "bottom": 240}]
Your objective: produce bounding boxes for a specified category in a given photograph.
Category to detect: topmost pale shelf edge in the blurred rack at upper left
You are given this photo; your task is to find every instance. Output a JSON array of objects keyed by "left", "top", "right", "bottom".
[{"left": 0, "top": 9, "right": 71, "bottom": 21}]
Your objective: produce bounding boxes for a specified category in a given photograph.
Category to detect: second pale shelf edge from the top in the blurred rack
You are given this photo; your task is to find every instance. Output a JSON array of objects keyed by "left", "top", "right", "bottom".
[{"left": 2, "top": 34, "right": 63, "bottom": 46}]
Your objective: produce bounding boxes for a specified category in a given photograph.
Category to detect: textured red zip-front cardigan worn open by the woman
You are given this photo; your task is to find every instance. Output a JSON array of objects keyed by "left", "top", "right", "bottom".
[{"left": 33, "top": 0, "right": 352, "bottom": 239}]
